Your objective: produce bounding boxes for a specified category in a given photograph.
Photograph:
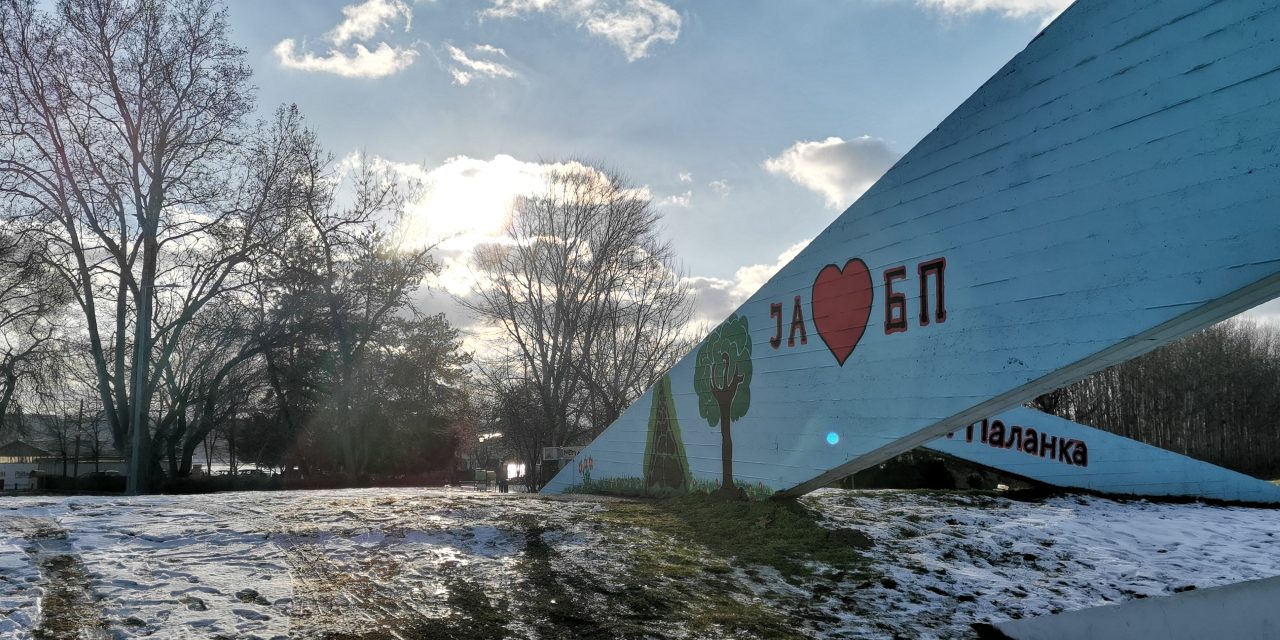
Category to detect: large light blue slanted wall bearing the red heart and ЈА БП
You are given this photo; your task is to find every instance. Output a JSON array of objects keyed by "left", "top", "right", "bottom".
[{"left": 547, "top": 0, "right": 1280, "bottom": 492}]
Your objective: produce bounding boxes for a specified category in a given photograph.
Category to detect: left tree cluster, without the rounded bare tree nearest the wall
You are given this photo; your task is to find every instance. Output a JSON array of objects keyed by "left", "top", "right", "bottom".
[{"left": 0, "top": 0, "right": 475, "bottom": 490}]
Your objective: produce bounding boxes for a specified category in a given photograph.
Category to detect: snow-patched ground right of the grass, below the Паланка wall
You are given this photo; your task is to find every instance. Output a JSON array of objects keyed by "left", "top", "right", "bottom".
[{"left": 810, "top": 490, "right": 1280, "bottom": 637}]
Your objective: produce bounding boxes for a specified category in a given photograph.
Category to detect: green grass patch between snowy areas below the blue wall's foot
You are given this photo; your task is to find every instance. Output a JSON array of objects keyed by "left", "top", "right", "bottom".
[{"left": 494, "top": 479, "right": 869, "bottom": 640}]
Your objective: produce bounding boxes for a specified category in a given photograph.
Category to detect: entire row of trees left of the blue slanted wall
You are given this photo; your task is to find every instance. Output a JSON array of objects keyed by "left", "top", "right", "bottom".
[{"left": 0, "top": 0, "right": 691, "bottom": 490}]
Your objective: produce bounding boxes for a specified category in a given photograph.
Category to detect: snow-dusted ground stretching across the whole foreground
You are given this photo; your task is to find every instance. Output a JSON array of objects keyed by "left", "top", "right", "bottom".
[{"left": 0, "top": 489, "right": 1280, "bottom": 639}]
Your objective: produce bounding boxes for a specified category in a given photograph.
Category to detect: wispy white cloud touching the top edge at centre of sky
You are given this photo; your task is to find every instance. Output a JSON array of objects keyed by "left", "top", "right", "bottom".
[{"left": 480, "top": 0, "right": 681, "bottom": 61}]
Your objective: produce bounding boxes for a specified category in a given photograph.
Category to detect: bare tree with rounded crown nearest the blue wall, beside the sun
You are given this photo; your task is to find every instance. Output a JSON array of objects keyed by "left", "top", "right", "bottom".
[{"left": 462, "top": 163, "right": 690, "bottom": 486}]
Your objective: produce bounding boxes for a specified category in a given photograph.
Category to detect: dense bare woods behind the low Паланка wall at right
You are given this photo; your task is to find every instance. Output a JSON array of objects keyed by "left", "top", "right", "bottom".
[{"left": 1033, "top": 320, "right": 1280, "bottom": 479}]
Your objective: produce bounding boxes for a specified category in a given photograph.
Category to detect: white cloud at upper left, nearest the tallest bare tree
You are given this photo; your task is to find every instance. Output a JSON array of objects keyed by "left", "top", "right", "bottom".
[{"left": 274, "top": 0, "right": 417, "bottom": 78}]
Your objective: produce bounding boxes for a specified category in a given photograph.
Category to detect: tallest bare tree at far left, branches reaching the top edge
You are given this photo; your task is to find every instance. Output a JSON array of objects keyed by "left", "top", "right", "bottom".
[{"left": 0, "top": 0, "right": 303, "bottom": 488}]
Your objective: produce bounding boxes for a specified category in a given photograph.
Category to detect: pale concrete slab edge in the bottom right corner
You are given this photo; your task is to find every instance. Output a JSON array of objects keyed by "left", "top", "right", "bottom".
[{"left": 995, "top": 577, "right": 1280, "bottom": 640}]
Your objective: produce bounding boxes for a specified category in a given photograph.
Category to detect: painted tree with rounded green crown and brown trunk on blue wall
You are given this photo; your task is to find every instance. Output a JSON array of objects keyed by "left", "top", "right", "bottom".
[{"left": 694, "top": 315, "right": 751, "bottom": 495}]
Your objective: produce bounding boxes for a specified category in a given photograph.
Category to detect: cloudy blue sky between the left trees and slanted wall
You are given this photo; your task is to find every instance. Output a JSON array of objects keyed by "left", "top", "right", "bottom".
[{"left": 228, "top": 0, "right": 1280, "bottom": 340}]
